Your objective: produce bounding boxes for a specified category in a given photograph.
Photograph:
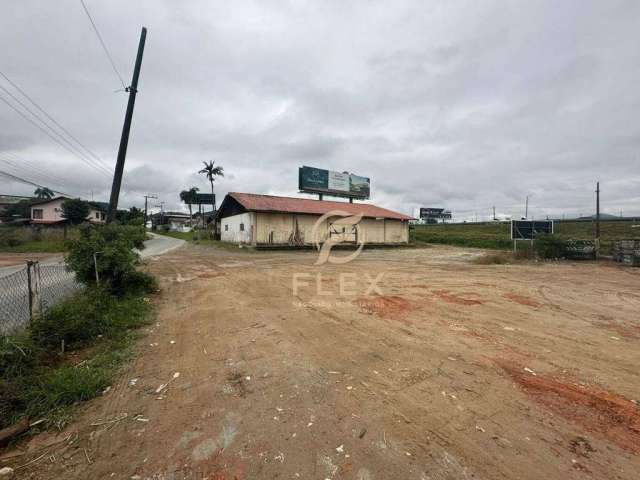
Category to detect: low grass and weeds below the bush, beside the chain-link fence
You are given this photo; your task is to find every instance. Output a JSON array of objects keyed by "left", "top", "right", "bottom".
[{"left": 0, "top": 290, "right": 151, "bottom": 428}]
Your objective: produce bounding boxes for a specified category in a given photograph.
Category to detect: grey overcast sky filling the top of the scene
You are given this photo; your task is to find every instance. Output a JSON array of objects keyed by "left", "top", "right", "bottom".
[{"left": 0, "top": 0, "right": 640, "bottom": 219}]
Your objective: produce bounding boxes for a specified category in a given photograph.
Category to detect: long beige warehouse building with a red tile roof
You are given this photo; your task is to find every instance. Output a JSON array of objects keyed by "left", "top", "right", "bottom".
[{"left": 216, "top": 192, "right": 412, "bottom": 246}]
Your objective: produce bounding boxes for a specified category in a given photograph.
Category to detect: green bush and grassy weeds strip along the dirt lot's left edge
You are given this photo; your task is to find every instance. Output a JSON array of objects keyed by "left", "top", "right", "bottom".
[{"left": 0, "top": 225, "right": 157, "bottom": 440}]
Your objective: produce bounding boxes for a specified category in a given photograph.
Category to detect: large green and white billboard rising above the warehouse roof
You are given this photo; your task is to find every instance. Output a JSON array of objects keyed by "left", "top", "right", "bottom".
[{"left": 298, "top": 166, "right": 371, "bottom": 199}]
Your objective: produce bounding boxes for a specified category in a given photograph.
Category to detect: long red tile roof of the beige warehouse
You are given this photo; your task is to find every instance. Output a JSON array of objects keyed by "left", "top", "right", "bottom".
[{"left": 229, "top": 192, "right": 413, "bottom": 220}]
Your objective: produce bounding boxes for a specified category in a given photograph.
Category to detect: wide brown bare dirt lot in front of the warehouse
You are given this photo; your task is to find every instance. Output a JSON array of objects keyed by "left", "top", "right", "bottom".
[{"left": 5, "top": 245, "right": 640, "bottom": 480}]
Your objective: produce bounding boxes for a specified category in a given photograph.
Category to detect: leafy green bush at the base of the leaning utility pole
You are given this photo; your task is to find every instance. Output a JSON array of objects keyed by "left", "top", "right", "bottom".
[{"left": 66, "top": 225, "right": 153, "bottom": 295}]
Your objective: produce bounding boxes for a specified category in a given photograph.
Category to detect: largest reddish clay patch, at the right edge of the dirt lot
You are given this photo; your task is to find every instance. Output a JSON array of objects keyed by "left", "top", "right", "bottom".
[{"left": 497, "top": 361, "right": 640, "bottom": 455}]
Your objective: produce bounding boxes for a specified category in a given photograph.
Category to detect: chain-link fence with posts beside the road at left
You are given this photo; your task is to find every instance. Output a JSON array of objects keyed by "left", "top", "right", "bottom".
[{"left": 0, "top": 262, "right": 81, "bottom": 335}]
